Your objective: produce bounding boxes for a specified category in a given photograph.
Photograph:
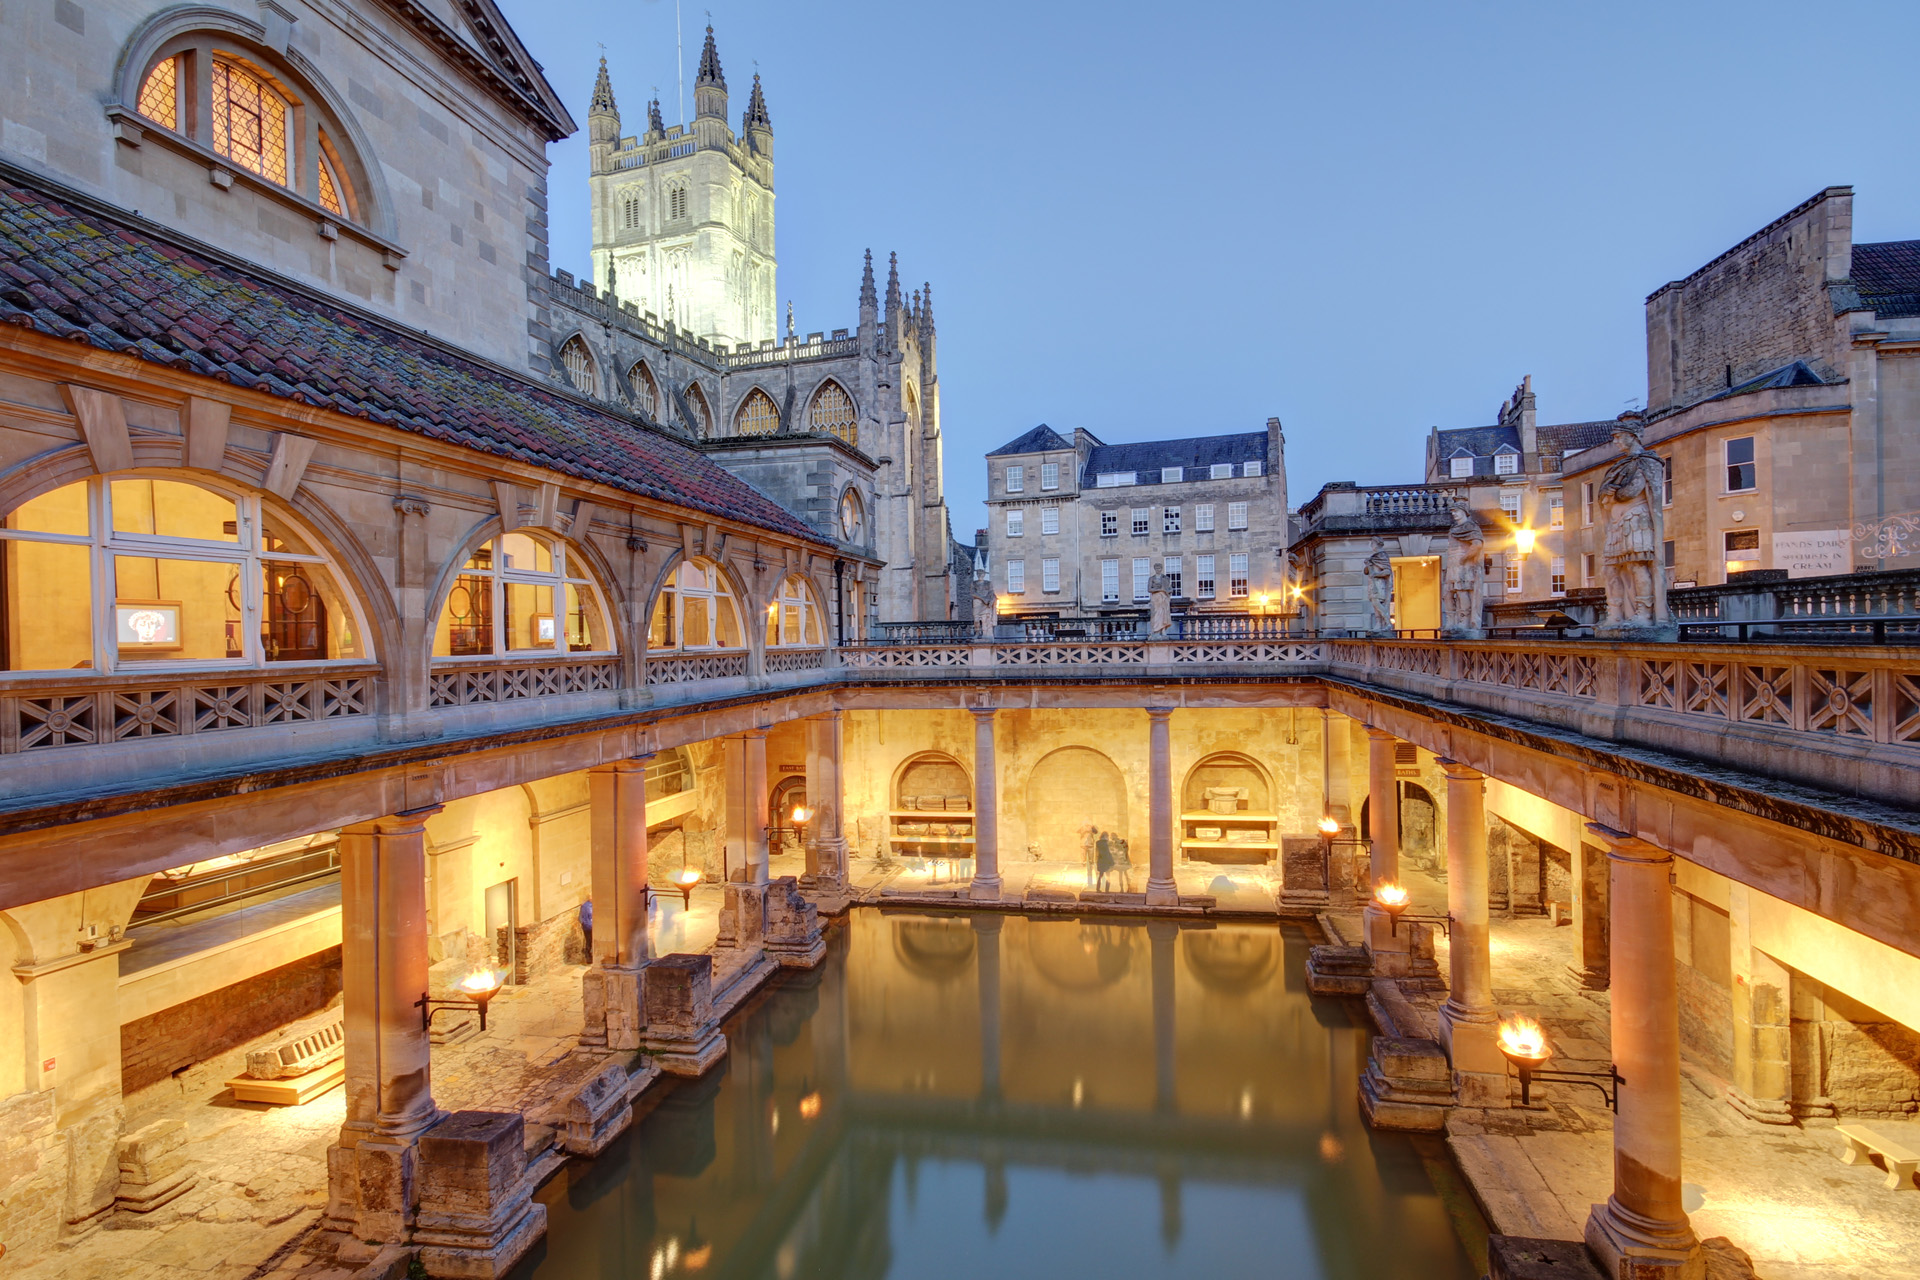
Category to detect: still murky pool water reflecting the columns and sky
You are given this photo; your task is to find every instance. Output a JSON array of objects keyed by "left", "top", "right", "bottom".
[{"left": 516, "top": 908, "right": 1484, "bottom": 1280}]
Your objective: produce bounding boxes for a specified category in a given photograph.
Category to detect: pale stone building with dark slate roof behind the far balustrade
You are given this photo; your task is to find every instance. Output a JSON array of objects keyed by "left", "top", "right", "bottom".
[{"left": 987, "top": 418, "right": 1286, "bottom": 614}]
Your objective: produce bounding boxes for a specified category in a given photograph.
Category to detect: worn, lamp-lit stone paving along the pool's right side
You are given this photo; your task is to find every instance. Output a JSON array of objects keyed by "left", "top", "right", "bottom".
[{"left": 1374, "top": 867, "right": 1920, "bottom": 1280}]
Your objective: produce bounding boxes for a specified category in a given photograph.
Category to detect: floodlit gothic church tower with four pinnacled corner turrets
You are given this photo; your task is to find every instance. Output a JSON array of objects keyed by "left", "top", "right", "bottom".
[{"left": 588, "top": 27, "right": 778, "bottom": 347}]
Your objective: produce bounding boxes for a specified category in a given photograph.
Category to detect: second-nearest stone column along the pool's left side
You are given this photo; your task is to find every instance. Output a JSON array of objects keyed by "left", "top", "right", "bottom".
[{"left": 580, "top": 754, "right": 653, "bottom": 1050}]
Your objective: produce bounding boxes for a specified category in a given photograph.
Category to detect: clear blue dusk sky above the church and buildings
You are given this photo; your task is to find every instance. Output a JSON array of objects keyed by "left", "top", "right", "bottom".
[{"left": 505, "top": 0, "right": 1920, "bottom": 539}]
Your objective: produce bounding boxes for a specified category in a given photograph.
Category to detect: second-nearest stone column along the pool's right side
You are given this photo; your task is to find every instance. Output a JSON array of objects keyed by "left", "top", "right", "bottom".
[{"left": 1440, "top": 760, "right": 1507, "bottom": 1107}]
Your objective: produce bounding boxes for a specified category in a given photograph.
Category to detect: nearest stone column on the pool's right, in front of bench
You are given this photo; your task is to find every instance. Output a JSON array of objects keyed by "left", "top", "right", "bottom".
[{"left": 1586, "top": 823, "right": 1701, "bottom": 1280}]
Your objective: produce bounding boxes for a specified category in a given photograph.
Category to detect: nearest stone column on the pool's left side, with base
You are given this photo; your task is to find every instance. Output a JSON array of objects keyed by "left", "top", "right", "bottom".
[{"left": 326, "top": 806, "right": 442, "bottom": 1242}]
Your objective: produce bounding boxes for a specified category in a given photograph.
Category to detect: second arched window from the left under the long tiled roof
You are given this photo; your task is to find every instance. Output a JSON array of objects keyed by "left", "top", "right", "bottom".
[{"left": 434, "top": 530, "right": 614, "bottom": 658}]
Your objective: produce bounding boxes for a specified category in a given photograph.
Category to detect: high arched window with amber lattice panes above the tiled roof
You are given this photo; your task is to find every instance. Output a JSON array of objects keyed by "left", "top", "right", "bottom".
[{"left": 134, "top": 42, "right": 365, "bottom": 221}]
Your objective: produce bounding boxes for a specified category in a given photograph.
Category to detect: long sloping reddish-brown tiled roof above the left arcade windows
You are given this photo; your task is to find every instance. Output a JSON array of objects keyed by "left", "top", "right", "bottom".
[{"left": 0, "top": 175, "right": 820, "bottom": 541}]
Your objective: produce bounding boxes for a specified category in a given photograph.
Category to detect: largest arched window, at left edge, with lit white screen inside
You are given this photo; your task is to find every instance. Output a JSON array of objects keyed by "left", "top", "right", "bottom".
[{"left": 0, "top": 474, "right": 369, "bottom": 672}]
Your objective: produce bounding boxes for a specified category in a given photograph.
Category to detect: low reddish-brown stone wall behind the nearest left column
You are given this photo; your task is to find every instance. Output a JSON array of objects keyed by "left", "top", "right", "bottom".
[{"left": 121, "top": 946, "right": 340, "bottom": 1094}]
